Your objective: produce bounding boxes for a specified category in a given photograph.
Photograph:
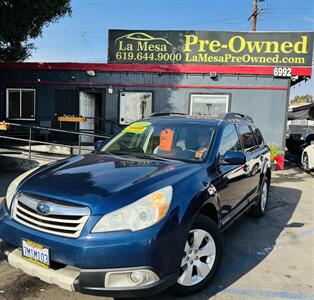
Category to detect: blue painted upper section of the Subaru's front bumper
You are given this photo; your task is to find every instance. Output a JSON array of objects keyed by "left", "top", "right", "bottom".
[{"left": 0, "top": 199, "right": 190, "bottom": 275}]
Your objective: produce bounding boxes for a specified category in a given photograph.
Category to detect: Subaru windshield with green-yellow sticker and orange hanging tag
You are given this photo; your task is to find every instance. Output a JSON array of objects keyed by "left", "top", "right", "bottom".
[{"left": 100, "top": 122, "right": 215, "bottom": 162}]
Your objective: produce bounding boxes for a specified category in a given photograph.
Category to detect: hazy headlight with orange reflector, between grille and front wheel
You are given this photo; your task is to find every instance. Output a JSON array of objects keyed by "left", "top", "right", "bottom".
[{"left": 92, "top": 186, "right": 172, "bottom": 233}]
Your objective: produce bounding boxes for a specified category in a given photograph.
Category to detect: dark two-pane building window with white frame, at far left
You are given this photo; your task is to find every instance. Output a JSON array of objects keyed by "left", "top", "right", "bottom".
[{"left": 7, "top": 89, "right": 36, "bottom": 120}]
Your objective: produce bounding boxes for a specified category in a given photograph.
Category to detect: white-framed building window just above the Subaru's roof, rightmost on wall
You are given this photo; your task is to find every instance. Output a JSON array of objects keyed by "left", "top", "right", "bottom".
[{"left": 190, "top": 94, "right": 229, "bottom": 116}]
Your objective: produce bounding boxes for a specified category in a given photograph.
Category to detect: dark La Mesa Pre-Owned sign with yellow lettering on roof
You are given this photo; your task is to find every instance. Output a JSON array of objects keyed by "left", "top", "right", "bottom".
[{"left": 108, "top": 30, "right": 313, "bottom": 67}]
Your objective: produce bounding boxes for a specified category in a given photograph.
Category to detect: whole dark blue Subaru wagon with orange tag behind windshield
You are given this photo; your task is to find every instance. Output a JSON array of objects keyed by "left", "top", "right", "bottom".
[{"left": 0, "top": 113, "right": 271, "bottom": 297}]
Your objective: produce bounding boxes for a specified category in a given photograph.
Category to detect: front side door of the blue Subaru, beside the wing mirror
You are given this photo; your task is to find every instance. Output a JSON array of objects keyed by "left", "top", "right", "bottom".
[{"left": 213, "top": 124, "right": 247, "bottom": 224}]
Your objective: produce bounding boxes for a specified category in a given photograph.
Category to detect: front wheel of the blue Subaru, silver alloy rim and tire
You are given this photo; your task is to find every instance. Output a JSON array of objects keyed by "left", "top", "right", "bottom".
[{"left": 170, "top": 216, "right": 223, "bottom": 296}]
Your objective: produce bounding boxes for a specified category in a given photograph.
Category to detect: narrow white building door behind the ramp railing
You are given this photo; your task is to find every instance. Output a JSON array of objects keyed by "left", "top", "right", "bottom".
[{"left": 80, "top": 92, "right": 96, "bottom": 143}]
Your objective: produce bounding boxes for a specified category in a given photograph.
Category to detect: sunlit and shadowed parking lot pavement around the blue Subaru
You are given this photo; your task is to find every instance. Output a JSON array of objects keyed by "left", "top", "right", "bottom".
[{"left": 0, "top": 167, "right": 314, "bottom": 300}]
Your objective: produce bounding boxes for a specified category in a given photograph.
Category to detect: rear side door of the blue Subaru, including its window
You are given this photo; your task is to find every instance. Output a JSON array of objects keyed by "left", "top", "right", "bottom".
[{"left": 237, "top": 124, "right": 263, "bottom": 200}]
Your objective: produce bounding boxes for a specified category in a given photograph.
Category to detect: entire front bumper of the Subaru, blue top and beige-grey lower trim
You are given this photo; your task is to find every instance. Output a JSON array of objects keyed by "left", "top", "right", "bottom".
[{"left": 0, "top": 198, "right": 189, "bottom": 297}]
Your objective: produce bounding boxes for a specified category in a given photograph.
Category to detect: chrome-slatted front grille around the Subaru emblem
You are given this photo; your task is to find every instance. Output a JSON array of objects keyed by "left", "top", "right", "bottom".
[{"left": 12, "top": 193, "right": 90, "bottom": 238}]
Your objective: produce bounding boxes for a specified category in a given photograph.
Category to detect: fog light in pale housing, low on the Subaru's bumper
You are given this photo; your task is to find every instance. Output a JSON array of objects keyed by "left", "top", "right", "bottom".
[{"left": 105, "top": 270, "right": 159, "bottom": 288}]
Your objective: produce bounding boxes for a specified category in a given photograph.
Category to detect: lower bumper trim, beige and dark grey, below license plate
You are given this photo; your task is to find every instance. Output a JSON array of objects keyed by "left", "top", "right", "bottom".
[{"left": 0, "top": 239, "right": 178, "bottom": 297}]
